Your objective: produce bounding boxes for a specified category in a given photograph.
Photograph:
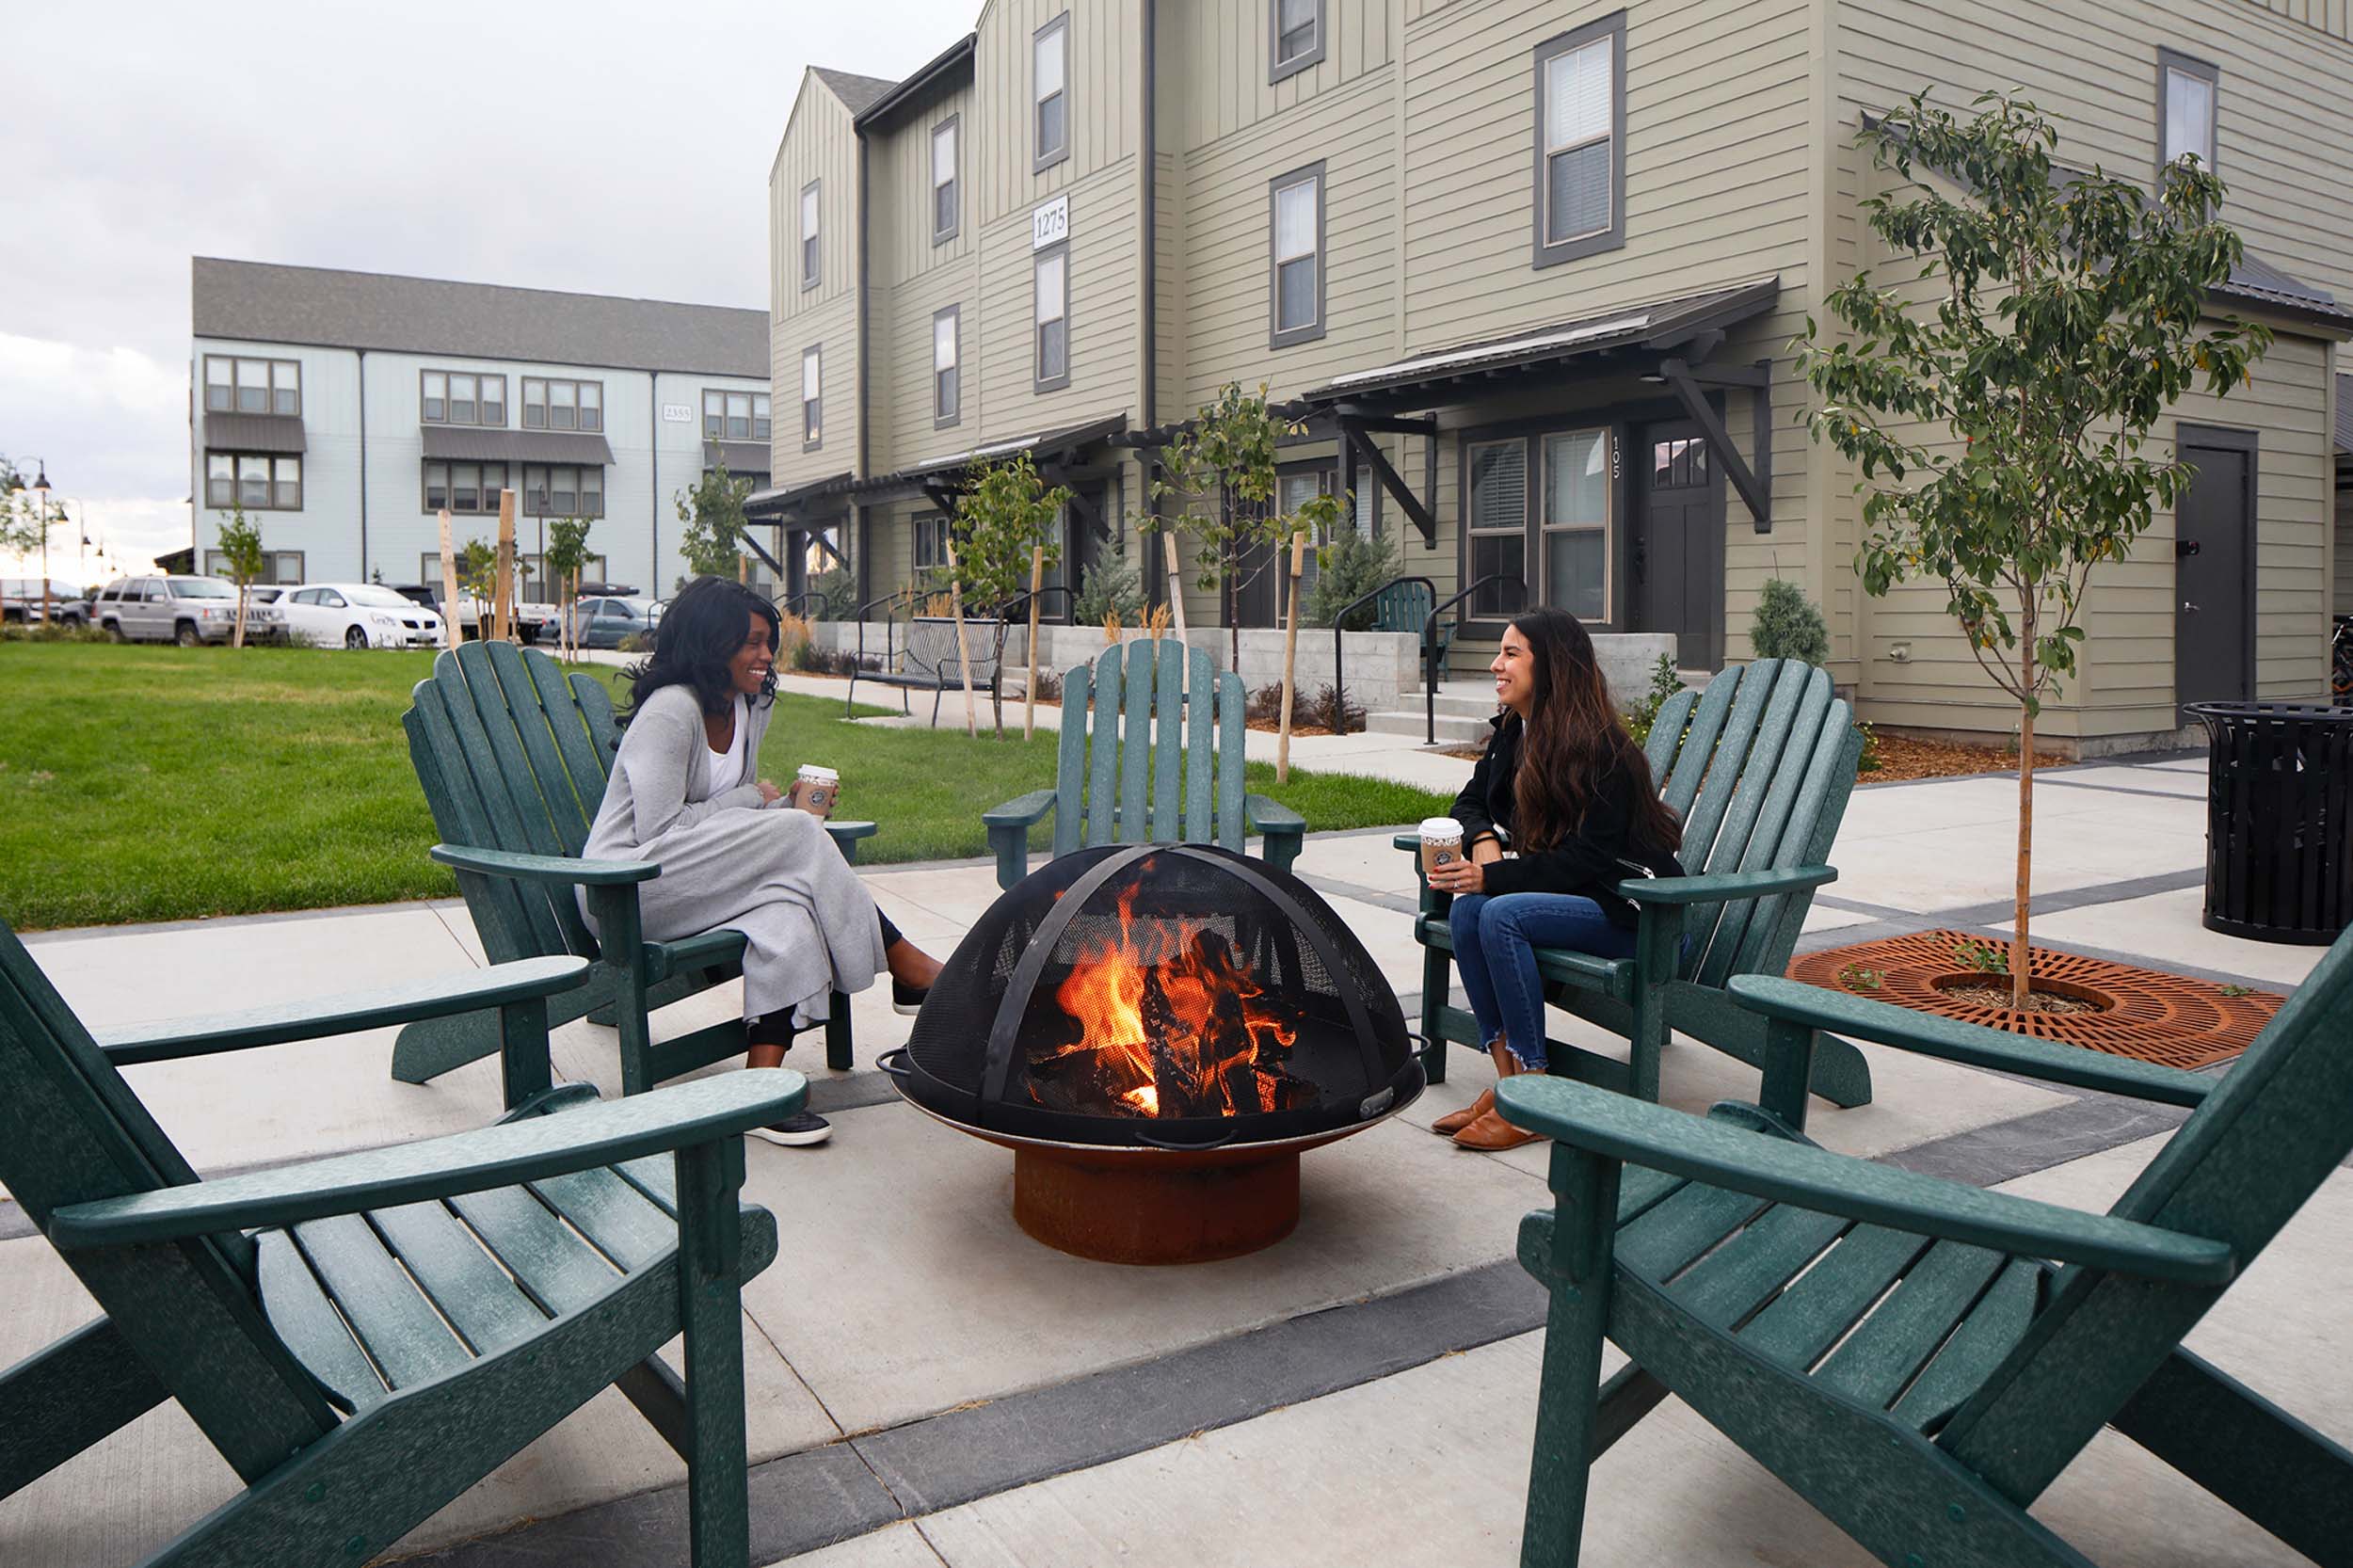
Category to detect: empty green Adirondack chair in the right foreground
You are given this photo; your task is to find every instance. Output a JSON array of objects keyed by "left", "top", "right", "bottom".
[{"left": 1497, "top": 918, "right": 2353, "bottom": 1568}]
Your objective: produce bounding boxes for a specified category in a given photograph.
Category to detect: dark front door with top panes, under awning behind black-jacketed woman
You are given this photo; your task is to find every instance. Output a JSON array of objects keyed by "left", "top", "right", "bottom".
[{"left": 1631, "top": 419, "right": 1725, "bottom": 668}]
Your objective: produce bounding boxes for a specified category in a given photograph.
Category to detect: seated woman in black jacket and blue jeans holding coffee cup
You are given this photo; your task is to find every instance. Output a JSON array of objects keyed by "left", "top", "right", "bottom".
[{"left": 1431, "top": 610, "right": 1683, "bottom": 1149}]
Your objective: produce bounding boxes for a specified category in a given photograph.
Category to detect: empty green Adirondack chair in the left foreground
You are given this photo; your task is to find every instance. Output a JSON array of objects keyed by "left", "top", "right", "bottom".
[{"left": 0, "top": 925, "right": 808, "bottom": 1568}]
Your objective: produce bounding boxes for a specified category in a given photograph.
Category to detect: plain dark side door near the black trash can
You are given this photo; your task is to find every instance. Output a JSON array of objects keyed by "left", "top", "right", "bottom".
[{"left": 2174, "top": 426, "right": 2254, "bottom": 701}]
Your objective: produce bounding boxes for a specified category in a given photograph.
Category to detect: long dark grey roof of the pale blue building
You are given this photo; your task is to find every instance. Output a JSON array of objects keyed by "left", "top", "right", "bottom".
[{"left": 191, "top": 257, "right": 770, "bottom": 381}]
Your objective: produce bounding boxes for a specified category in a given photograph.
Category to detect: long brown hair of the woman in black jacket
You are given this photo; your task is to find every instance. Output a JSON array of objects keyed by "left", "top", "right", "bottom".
[{"left": 1511, "top": 610, "right": 1683, "bottom": 853}]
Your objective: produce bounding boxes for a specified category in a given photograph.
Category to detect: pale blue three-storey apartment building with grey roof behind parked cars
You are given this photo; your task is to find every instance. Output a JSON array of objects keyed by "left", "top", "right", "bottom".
[{"left": 188, "top": 257, "right": 770, "bottom": 593}]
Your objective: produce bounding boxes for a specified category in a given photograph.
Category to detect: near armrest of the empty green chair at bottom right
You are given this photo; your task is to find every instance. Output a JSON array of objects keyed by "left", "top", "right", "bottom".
[{"left": 1495, "top": 1074, "right": 2238, "bottom": 1286}]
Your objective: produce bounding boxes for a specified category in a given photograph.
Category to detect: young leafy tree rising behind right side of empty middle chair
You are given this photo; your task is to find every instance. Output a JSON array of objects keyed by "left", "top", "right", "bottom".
[{"left": 1137, "top": 384, "right": 1330, "bottom": 668}]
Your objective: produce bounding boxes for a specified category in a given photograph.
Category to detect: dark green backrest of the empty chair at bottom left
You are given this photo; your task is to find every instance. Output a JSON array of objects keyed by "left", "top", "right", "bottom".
[{"left": 0, "top": 925, "right": 337, "bottom": 1480}]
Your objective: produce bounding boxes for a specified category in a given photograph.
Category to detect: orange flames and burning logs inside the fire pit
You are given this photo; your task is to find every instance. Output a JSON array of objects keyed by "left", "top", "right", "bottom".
[{"left": 1043, "top": 886, "right": 1299, "bottom": 1116}]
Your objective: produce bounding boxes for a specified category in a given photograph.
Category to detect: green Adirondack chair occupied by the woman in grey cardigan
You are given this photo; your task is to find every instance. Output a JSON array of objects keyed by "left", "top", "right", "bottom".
[{"left": 393, "top": 643, "right": 875, "bottom": 1095}]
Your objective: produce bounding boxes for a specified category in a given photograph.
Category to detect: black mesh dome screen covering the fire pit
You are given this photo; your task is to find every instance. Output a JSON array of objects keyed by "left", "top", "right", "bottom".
[{"left": 904, "top": 845, "right": 1421, "bottom": 1146}]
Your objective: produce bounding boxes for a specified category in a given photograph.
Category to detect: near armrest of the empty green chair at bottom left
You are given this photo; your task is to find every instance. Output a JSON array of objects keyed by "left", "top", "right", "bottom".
[{"left": 50, "top": 1066, "right": 809, "bottom": 1250}]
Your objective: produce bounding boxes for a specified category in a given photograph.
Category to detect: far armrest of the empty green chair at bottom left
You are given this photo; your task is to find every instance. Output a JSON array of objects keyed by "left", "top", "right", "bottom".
[{"left": 99, "top": 958, "right": 588, "bottom": 1066}]
